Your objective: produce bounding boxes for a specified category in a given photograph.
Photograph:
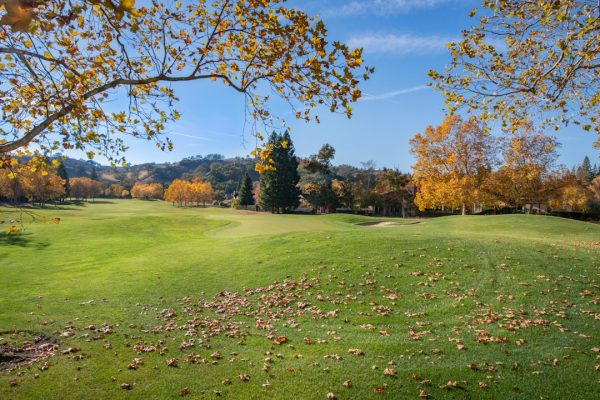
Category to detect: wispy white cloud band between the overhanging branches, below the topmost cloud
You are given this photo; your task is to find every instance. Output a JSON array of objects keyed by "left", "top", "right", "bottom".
[{"left": 347, "top": 34, "right": 456, "bottom": 55}]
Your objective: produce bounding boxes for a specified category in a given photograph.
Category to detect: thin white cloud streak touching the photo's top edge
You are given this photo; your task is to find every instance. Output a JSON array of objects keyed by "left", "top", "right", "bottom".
[{"left": 325, "top": 0, "right": 452, "bottom": 16}]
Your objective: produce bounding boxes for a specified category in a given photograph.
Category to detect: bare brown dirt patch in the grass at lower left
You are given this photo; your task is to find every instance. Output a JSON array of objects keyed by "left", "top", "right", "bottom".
[{"left": 0, "top": 331, "right": 58, "bottom": 371}]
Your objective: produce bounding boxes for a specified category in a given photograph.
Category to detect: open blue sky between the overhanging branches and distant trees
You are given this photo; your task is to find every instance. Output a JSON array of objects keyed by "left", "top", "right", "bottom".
[{"left": 70, "top": 0, "right": 600, "bottom": 171}]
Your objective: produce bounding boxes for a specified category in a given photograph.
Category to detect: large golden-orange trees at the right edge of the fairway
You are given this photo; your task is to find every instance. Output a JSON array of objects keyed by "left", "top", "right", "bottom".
[{"left": 410, "top": 116, "right": 600, "bottom": 214}]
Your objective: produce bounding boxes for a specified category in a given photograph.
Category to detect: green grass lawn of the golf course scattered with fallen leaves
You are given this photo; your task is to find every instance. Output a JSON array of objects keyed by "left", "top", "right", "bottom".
[{"left": 0, "top": 200, "right": 600, "bottom": 399}]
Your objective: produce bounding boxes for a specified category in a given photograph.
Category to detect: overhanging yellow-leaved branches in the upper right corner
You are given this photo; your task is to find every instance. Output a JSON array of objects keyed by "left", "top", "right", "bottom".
[{"left": 429, "top": 0, "right": 600, "bottom": 145}]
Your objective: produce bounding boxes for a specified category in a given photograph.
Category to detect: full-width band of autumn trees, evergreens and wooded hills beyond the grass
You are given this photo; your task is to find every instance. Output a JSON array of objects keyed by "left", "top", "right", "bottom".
[{"left": 0, "top": 123, "right": 600, "bottom": 217}]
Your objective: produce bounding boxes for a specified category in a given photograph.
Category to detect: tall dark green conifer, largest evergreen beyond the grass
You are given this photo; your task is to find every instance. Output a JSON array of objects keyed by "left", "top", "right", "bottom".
[{"left": 260, "top": 132, "right": 300, "bottom": 213}]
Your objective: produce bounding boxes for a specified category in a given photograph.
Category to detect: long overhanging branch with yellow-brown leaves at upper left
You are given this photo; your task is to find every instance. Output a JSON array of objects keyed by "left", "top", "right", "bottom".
[{"left": 0, "top": 0, "right": 372, "bottom": 166}]
